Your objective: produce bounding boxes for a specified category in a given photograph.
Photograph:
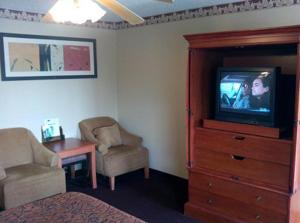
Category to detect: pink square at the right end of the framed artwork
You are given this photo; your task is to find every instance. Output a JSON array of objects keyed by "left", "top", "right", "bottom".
[{"left": 64, "top": 45, "right": 91, "bottom": 71}]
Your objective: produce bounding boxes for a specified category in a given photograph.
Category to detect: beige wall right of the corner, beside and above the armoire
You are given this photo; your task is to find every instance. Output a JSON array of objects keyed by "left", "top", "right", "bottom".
[{"left": 117, "top": 5, "right": 300, "bottom": 177}]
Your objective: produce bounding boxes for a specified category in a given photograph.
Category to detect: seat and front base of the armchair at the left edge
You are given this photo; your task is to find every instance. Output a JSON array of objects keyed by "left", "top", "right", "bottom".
[{"left": 0, "top": 164, "right": 66, "bottom": 209}]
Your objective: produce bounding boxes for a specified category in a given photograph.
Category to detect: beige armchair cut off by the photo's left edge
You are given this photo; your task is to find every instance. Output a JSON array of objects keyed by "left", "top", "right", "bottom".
[{"left": 0, "top": 128, "right": 66, "bottom": 209}]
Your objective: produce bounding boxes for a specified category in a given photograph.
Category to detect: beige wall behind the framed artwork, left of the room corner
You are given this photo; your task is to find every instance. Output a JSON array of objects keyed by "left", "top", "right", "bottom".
[{"left": 0, "top": 19, "right": 118, "bottom": 139}]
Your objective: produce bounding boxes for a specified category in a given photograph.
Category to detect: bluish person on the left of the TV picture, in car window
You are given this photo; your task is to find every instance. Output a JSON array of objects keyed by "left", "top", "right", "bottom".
[{"left": 232, "top": 80, "right": 251, "bottom": 109}]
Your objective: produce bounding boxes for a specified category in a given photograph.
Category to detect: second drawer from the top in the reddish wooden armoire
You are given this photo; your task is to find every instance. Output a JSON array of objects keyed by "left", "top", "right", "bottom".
[{"left": 194, "top": 148, "right": 290, "bottom": 192}]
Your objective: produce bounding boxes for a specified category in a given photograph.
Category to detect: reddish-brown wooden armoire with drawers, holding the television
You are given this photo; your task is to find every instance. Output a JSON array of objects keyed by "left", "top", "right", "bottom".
[{"left": 185, "top": 26, "right": 300, "bottom": 223}]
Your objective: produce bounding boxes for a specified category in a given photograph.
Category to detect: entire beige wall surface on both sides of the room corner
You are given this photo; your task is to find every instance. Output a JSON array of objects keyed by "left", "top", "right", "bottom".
[{"left": 0, "top": 6, "right": 300, "bottom": 177}]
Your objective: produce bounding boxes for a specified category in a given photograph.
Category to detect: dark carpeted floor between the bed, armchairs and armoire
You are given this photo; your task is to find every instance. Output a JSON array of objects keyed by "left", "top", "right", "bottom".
[{"left": 67, "top": 170, "right": 197, "bottom": 223}]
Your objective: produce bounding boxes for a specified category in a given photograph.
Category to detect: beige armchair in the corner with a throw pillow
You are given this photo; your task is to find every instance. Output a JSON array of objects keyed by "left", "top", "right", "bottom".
[{"left": 79, "top": 117, "right": 149, "bottom": 190}]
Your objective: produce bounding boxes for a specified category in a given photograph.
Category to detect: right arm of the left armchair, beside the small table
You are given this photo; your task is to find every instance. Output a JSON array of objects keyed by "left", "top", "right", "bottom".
[{"left": 29, "top": 132, "right": 59, "bottom": 167}]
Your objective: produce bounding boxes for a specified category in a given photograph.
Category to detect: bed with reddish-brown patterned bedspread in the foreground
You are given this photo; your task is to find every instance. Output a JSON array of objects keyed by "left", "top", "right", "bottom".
[{"left": 0, "top": 192, "right": 144, "bottom": 223}]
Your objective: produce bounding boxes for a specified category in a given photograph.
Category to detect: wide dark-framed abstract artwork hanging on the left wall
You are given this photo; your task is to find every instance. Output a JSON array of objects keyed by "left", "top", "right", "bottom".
[{"left": 0, "top": 33, "right": 97, "bottom": 81}]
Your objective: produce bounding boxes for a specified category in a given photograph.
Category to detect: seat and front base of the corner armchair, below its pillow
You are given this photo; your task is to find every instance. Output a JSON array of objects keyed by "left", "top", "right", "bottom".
[{"left": 96, "top": 145, "right": 148, "bottom": 176}]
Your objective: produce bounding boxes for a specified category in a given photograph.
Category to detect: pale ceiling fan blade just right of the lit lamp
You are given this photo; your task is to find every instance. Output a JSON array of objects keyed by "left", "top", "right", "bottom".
[{"left": 95, "top": 0, "right": 144, "bottom": 25}]
